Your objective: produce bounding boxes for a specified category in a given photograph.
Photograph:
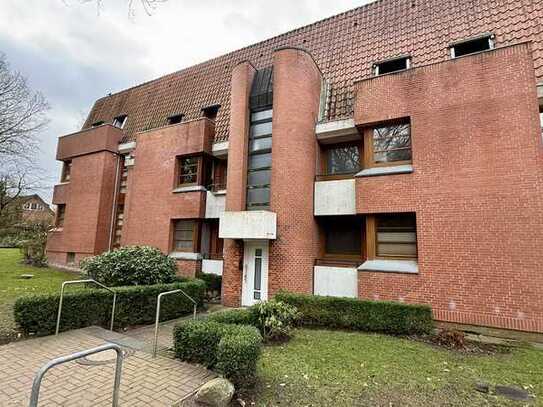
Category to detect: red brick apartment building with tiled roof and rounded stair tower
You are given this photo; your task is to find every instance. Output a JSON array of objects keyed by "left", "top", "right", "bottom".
[{"left": 47, "top": 0, "right": 543, "bottom": 333}]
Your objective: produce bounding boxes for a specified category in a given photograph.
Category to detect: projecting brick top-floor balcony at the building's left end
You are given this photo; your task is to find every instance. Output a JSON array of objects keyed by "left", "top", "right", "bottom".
[{"left": 57, "top": 124, "right": 123, "bottom": 161}]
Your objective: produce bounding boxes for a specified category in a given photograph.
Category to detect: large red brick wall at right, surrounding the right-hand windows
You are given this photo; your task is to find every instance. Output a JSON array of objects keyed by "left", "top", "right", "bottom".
[{"left": 355, "top": 44, "right": 543, "bottom": 332}]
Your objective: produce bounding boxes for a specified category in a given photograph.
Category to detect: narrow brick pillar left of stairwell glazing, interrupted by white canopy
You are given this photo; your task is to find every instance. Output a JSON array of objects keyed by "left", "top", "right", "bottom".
[{"left": 222, "top": 62, "right": 256, "bottom": 307}]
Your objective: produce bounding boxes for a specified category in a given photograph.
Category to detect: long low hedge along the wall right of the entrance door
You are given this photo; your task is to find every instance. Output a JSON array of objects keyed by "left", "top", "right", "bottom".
[{"left": 275, "top": 291, "right": 434, "bottom": 335}]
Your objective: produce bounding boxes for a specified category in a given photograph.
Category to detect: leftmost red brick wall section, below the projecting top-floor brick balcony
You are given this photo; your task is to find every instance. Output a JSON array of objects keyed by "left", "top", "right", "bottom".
[{"left": 47, "top": 151, "right": 118, "bottom": 263}]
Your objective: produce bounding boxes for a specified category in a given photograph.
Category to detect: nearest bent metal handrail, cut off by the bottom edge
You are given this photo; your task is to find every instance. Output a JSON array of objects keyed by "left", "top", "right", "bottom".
[{"left": 29, "top": 343, "right": 124, "bottom": 407}]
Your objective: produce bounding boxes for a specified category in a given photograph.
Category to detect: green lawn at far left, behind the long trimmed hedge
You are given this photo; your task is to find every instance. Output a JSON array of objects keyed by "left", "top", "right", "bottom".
[{"left": 0, "top": 249, "right": 80, "bottom": 343}]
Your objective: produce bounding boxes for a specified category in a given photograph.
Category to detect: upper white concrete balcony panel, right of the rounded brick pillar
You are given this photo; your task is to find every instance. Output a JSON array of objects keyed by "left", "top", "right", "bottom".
[{"left": 314, "top": 178, "right": 356, "bottom": 216}]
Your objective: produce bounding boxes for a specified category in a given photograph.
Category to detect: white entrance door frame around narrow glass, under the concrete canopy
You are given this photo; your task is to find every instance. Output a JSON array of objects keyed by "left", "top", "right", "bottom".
[{"left": 241, "top": 240, "right": 269, "bottom": 307}]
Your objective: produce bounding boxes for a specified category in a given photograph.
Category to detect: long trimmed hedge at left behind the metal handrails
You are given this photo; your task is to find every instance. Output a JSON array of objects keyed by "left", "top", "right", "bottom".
[{"left": 14, "top": 280, "right": 205, "bottom": 335}]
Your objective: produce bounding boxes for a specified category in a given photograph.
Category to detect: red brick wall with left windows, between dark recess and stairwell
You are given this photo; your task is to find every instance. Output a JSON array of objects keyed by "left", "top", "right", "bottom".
[{"left": 121, "top": 119, "right": 213, "bottom": 253}]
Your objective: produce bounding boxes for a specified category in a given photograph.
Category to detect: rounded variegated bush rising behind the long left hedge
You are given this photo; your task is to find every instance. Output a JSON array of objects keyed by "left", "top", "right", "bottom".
[{"left": 81, "top": 246, "right": 177, "bottom": 287}]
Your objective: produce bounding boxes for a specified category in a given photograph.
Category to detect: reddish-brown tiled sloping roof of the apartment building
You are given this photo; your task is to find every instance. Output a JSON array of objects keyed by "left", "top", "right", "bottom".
[{"left": 84, "top": 0, "right": 543, "bottom": 142}]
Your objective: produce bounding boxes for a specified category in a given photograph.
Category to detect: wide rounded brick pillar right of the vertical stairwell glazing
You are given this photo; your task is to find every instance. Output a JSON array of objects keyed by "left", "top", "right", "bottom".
[{"left": 268, "top": 48, "right": 321, "bottom": 297}]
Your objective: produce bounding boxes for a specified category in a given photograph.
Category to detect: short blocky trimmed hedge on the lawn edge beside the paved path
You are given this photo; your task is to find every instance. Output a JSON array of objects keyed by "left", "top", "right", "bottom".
[{"left": 173, "top": 320, "right": 262, "bottom": 387}]
